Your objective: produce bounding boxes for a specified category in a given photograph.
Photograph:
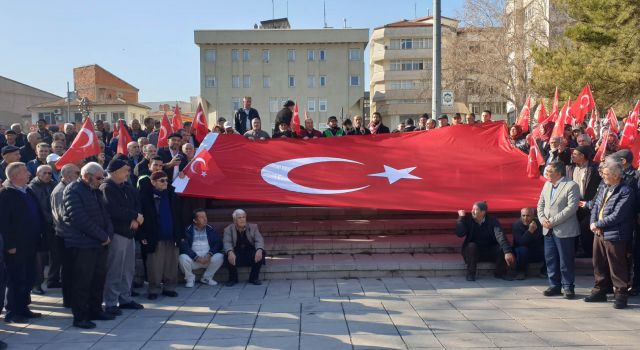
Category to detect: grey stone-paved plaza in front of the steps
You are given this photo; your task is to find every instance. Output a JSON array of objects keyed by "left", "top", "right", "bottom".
[{"left": 0, "top": 276, "right": 640, "bottom": 350}]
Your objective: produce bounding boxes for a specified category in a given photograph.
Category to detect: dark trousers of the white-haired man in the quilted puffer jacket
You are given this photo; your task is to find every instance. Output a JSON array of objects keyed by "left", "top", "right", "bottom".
[{"left": 67, "top": 247, "right": 107, "bottom": 321}]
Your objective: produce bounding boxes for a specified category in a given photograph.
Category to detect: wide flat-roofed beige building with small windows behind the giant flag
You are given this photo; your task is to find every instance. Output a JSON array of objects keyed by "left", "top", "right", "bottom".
[{"left": 195, "top": 19, "right": 369, "bottom": 130}]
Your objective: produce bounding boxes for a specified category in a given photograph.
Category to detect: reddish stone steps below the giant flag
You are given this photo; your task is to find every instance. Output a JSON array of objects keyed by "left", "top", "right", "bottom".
[{"left": 207, "top": 201, "right": 592, "bottom": 280}]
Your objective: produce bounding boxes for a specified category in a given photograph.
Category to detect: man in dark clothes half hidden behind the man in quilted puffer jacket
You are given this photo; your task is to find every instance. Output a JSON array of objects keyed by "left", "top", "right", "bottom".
[{"left": 47, "top": 163, "right": 80, "bottom": 307}]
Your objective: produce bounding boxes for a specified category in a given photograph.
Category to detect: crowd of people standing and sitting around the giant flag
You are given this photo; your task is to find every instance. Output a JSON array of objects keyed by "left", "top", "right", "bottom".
[{"left": 0, "top": 97, "right": 640, "bottom": 342}]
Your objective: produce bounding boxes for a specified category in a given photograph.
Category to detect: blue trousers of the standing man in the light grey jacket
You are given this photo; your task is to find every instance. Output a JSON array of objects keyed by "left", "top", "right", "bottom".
[{"left": 544, "top": 230, "right": 576, "bottom": 290}]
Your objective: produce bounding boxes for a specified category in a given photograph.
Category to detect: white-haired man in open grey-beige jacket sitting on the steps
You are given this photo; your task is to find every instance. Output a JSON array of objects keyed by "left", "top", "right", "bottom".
[{"left": 223, "top": 209, "right": 265, "bottom": 287}]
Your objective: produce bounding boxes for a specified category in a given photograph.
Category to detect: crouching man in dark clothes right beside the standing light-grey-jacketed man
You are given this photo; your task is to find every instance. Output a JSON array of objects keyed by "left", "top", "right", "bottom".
[{"left": 511, "top": 208, "right": 546, "bottom": 280}]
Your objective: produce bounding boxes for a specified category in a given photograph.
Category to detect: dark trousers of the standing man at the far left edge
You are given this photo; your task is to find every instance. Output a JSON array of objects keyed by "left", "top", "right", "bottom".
[{"left": 5, "top": 251, "right": 36, "bottom": 315}]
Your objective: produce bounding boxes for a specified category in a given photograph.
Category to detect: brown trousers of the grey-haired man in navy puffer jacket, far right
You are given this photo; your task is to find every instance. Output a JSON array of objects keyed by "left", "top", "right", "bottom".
[{"left": 592, "top": 236, "right": 629, "bottom": 294}]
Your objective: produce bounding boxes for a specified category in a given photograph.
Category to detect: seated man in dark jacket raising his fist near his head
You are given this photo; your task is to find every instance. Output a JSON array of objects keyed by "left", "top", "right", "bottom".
[{"left": 456, "top": 202, "right": 516, "bottom": 281}]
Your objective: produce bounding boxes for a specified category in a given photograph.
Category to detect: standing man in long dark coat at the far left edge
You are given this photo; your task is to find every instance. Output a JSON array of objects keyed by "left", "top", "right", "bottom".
[{"left": 0, "top": 162, "right": 44, "bottom": 323}]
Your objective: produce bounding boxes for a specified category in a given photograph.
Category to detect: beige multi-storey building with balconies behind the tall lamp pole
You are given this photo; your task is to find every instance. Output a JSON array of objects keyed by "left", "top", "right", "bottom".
[{"left": 369, "top": 17, "right": 506, "bottom": 127}]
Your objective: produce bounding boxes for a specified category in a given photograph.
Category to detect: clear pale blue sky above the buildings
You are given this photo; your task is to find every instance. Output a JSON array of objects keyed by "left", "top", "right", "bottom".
[{"left": 0, "top": 0, "right": 464, "bottom": 101}]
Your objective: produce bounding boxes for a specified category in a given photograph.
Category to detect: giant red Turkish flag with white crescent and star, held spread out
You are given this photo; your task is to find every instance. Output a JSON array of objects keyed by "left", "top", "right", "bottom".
[{"left": 174, "top": 123, "right": 543, "bottom": 212}]
